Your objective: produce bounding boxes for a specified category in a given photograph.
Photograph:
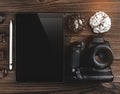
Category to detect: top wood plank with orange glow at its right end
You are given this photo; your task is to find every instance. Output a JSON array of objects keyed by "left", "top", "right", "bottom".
[{"left": 0, "top": 0, "right": 120, "bottom": 13}]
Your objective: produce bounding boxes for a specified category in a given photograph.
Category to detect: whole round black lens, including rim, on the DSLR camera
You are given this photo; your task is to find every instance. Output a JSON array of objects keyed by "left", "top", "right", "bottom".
[{"left": 93, "top": 45, "right": 113, "bottom": 68}]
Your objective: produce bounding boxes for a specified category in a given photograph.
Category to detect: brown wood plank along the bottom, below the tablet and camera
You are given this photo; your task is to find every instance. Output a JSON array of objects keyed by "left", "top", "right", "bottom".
[{"left": 0, "top": 71, "right": 120, "bottom": 94}]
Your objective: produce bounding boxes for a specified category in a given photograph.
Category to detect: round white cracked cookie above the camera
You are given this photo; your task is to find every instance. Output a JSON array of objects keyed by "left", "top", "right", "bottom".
[{"left": 89, "top": 11, "right": 111, "bottom": 33}]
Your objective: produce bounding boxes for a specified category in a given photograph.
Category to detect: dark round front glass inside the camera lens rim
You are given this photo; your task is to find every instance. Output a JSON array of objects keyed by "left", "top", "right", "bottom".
[{"left": 95, "top": 49, "right": 111, "bottom": 63}]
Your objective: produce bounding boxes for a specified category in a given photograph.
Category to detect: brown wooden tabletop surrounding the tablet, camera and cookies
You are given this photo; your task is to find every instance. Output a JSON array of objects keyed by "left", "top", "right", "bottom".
[{"left": 0, "top": 0, "right": 120, "bottom": 94}]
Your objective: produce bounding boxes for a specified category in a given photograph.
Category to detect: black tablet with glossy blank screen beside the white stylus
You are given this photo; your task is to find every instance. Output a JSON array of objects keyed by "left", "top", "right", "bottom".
[{"left": 15, "top": 13, "right": 63, "bottom": 82}]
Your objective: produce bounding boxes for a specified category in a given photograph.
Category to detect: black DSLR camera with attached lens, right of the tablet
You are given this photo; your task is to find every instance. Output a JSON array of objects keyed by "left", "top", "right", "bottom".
[{"left": 65, "top": 36, "right": 114, "bottom": 82}]
